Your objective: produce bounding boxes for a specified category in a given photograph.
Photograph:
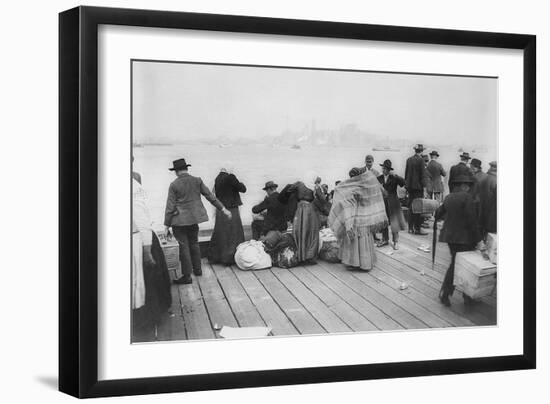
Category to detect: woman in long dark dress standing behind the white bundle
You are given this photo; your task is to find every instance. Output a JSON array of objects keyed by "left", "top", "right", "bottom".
[{"left": 207, "top": 170, "right": 246, "bottom": 265}]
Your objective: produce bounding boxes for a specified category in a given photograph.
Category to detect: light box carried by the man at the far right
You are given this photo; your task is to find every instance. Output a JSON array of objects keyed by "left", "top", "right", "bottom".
[{"left": 454, "top": 251, "right": 497, "bottom": 299}]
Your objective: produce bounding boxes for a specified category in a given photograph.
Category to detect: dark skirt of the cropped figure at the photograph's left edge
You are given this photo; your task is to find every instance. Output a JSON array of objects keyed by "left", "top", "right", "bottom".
[{"left": 132, "top": 232, "right": 172, "bottom": 342}]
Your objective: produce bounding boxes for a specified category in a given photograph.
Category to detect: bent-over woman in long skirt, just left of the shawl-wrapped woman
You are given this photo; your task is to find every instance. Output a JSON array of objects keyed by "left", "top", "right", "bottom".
[{"left": 279, "top": 181, "right": 320, "bottom": 263}]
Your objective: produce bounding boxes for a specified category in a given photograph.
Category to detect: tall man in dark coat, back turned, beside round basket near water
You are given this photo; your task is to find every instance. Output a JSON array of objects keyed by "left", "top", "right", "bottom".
[{"left": 405, "top": 144, "right": 428, "bottom": 236}]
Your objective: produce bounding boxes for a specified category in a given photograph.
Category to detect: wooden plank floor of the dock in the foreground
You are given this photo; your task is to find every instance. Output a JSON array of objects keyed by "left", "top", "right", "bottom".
[{"left": 149, "top": 227, "right": 497, "bottom": 341}]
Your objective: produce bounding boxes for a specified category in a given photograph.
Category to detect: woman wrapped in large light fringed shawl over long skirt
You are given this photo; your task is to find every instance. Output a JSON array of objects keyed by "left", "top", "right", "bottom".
[{"left": 328, "top": 169, "right": 388, "bottom": 271}]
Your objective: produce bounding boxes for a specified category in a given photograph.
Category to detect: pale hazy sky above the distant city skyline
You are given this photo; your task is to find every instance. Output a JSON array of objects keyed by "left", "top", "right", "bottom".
[{"left": 133, "top": 62, "right": 497, "bottom": 145}]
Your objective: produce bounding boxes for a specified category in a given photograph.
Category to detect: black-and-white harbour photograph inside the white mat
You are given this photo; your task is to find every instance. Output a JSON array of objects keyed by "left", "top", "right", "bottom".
[{"left": 133, "top": 59, "right": 500, "bottom": 343}]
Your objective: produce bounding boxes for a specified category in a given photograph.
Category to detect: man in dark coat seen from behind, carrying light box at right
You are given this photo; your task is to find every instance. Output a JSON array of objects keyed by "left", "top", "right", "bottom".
[{"left": 435, "top": 175, "right": 480, "bottom": 306}]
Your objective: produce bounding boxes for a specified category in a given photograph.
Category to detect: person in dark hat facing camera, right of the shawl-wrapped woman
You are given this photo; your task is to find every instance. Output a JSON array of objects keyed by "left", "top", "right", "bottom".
[{"left": 377, "top": 160, "right": 406, "bottom": 250}]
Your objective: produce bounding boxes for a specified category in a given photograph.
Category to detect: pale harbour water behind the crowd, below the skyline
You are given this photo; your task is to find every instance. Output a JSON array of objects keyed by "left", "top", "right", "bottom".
[{"left": 133, "top": 145, "right": 496, "bottom": 229}]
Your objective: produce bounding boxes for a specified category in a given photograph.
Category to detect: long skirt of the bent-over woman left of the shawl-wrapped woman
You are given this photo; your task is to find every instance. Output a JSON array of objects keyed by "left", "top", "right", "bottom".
[{"left": 292, "top": 201, "right": 320, "bottom": 262}]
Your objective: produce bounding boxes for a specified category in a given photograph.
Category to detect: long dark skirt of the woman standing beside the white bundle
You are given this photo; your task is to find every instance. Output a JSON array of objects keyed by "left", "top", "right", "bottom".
[{"left": 207, "top": 208, "right": 244, "bottom": 265}]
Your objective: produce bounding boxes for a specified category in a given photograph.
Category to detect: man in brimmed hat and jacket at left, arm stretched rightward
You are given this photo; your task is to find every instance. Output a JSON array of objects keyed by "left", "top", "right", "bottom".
[{"left": 164, "top": 159, "right": 231, "bottom": 284}]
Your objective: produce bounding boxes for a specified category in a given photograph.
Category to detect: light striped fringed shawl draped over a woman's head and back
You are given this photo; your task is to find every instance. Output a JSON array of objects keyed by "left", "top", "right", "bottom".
[{"left": 328, "top": 171, "right": 388, "bottom": 239}]
